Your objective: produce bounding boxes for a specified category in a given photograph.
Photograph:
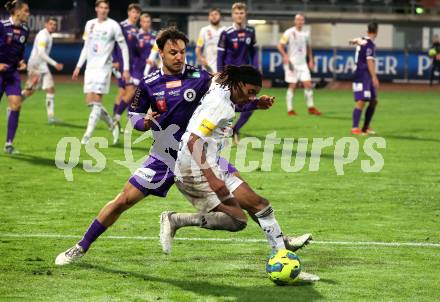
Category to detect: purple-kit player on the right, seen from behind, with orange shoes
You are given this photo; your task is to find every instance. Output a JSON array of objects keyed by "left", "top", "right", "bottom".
[{"left": 350, "top": 22, "right": 379, "bottom": 135}]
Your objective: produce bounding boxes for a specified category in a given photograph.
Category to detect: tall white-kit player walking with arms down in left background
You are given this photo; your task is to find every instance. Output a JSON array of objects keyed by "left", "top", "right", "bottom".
[{"left": 72, "top": 0, "right": 130, "bottom": 145}]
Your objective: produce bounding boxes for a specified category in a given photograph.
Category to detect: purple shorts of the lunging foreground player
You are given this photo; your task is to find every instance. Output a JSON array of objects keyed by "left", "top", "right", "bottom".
[{"left": 128, "top": 155, "right": 237, "bottom": 197}]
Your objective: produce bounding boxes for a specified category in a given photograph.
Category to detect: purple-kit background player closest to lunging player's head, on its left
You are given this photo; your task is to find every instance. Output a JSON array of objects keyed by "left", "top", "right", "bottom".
[{"left": 132, "top": 13, "right": 157, "bottom": 84}]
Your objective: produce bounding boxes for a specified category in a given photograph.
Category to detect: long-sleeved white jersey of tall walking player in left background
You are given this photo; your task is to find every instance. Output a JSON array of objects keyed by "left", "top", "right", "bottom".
[{"left": 77, "top": 18, "right": 130, "bottom": 70}]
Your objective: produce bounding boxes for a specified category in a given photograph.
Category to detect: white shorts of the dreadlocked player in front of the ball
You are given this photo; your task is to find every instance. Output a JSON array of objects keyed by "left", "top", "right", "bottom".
[{"left": 175, "top": 158, "right": 243, "bottom": 213}]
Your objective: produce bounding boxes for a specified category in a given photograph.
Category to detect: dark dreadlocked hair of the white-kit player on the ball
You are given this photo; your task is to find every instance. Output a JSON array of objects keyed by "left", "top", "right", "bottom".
[{"left": 215, "top": 65, "right": 262, "bottom": 90}]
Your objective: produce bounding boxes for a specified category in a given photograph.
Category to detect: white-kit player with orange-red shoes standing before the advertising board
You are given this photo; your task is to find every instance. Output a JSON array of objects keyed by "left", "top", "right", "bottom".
[{"left": 278, "top": 14, "right": 321, "bottom": 115}]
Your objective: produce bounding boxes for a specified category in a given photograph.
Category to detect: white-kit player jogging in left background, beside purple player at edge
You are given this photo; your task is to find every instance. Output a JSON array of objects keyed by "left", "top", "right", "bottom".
[{"left": 21, "top": 17, "right": 64, "bottom": 124}]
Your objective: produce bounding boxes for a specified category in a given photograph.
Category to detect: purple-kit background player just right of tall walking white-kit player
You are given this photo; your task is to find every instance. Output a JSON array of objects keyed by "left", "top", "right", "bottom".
[{"left": 113, "top": 3, "right": 142, "bottom": 122}]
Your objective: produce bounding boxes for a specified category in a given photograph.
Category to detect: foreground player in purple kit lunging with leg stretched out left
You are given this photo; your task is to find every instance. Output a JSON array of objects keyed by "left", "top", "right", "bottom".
[{"left": 55, "top": 28, "right": 305, "bottom": 265}]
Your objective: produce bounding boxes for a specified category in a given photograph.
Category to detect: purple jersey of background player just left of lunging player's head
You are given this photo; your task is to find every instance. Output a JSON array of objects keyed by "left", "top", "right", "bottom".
[{"left": 133, "top": 29, "right": 157, "bottom": 78}]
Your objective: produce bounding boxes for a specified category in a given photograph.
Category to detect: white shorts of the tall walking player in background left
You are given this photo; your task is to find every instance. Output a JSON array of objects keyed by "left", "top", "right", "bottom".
[{"left": 84, "top": 66, "right": 112, "bottom": 94}]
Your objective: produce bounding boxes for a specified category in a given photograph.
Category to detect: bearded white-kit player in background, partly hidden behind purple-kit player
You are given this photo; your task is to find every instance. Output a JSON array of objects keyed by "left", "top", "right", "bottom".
[{"left": 196, "top": 8, "right": 224, "bottom": 73}]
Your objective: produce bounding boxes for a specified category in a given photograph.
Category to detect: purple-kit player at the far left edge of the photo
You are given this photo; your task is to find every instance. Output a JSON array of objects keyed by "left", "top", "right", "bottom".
[{"left": 0, "top": 0, "right": 30, "bottom": 154}]
